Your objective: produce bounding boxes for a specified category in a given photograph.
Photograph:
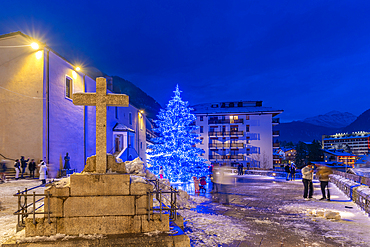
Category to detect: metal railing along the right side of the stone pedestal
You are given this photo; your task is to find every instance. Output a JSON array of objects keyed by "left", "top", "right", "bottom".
[{"left": 147, "top": 179, "right": 179, "bottom": 221}]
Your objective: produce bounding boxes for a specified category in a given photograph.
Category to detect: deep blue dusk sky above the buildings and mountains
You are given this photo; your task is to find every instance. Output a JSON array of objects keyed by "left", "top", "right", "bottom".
[{"left": 0, "top": 0, "right": 370, "bottom": 122}]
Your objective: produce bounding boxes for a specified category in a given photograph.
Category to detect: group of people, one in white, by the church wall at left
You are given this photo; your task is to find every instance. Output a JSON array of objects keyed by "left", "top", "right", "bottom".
[{"left": 14, "top": 156, "right": 47, "bottom": 184}]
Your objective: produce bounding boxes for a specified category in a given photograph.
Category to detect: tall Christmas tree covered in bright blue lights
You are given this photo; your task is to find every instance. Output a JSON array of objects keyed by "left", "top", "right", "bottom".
[{"left": 148, "top": 85, "right": 207, "bottom": 182}]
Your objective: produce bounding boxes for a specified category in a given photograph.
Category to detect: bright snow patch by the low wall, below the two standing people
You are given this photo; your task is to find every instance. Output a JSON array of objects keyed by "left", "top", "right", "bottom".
[{"left": 280, "top": 183, "right": 370, "bottom": 246}]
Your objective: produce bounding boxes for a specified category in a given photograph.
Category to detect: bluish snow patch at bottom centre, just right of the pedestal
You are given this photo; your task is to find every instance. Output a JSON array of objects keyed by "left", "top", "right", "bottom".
[{"left": 179, "top": 210, "right": 249, "bottom": 246}]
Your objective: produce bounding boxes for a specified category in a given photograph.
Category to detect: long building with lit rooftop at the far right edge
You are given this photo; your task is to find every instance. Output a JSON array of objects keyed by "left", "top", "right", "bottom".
[{"left": 322, "top": 131, "right": 370, "bottom": 155}]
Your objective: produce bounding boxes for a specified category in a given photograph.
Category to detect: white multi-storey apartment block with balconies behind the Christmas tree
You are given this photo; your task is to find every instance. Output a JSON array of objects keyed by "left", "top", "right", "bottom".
[{"left": 192, "top": 101, "right": 283, "bottom": 169}]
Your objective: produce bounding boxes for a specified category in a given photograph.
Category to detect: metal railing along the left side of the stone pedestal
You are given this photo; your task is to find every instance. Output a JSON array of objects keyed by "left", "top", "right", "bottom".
[{"left": 13, "top": 182, "right": 52, "bottom": 232}]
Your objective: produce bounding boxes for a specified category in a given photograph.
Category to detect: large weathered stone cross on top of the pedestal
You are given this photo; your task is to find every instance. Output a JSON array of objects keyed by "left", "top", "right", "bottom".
[{"left": 73, "top": 77, "right": 129, "bottom": 173}]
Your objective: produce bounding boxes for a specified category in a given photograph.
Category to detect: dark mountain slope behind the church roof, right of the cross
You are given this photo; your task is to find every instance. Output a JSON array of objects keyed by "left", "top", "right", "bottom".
[{"left": 112, "top": 76, "right": 162, "bottom": 119}]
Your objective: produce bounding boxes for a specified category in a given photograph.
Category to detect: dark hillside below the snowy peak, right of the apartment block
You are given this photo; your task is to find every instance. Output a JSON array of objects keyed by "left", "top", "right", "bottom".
[{"left": 274, "top": 121, "right": 338, "bottom": 143}]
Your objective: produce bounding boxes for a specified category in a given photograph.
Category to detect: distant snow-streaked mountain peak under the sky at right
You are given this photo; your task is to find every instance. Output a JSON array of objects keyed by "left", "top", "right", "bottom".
[{"left": 302, "top": 111, "right": 357, "bottom": 128}]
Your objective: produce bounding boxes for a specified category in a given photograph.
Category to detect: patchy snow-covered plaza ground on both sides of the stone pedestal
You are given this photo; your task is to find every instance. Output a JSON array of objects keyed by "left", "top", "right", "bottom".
[{"left": 0, "top": 175, "right": 370, "bottom": 246}]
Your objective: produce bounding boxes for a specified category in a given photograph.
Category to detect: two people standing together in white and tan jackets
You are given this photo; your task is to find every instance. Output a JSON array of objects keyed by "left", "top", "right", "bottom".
[{"left": 302, "top": 163, "right": 333, "bottom": 201}]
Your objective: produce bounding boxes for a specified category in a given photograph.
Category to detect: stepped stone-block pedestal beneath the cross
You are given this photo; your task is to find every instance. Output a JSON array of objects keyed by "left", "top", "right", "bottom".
[{"left": 25, "top": 174, "right": 169, "bottom": 237}]
